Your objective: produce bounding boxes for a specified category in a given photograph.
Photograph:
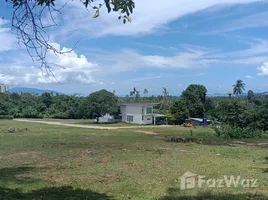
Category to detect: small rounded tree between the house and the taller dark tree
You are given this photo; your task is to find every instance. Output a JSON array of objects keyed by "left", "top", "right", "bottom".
[{"left": 170, "top": 98, "right": 189, "bottom": 124}]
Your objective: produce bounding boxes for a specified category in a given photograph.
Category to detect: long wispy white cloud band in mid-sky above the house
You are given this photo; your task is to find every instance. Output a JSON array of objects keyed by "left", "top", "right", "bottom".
[{"left": 100, "top": 47, "right": 218, "bottom": 73}]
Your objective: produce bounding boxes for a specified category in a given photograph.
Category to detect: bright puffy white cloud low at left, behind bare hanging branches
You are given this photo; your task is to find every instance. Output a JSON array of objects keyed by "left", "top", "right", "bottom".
[{"left": 0, "top": 44, "right": 102, "bottom": 84}]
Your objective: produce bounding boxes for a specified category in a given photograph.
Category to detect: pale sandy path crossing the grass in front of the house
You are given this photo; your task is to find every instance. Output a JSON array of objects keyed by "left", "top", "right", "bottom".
[{"left": 14, "top": 119, "right": 171, "bottom": 130}]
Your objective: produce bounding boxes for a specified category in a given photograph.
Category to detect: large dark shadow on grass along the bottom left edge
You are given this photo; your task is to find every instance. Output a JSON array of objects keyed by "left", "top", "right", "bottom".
[{"left": 0, "top": 186, "right": 112, "bottom": 200}]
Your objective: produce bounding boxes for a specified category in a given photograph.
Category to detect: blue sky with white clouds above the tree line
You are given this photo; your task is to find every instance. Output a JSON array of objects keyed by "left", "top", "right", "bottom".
[{"left": 0, "top": 0, "right": 268, "bottom": 95}]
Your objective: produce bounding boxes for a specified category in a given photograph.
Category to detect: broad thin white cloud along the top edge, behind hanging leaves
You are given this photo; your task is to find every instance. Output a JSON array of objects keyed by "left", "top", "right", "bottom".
[{"left": 52, "top": 0, "right": 261, "bottom": 39}]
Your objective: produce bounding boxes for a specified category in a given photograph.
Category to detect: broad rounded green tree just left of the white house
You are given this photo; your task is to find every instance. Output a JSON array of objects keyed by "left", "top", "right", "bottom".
[{"left": 85, "top": 90, "right": 118, "bottom": 123}]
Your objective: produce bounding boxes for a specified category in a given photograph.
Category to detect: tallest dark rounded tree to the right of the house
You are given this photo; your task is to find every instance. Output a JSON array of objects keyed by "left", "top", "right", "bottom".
[{"left": 181, "top": 84, "right": 207, "bottom": 117}]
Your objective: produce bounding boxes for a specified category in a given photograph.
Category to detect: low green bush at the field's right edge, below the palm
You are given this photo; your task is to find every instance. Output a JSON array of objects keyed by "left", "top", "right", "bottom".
[{"left": 214, "top": 125, "right": 264, "bottom": 139}]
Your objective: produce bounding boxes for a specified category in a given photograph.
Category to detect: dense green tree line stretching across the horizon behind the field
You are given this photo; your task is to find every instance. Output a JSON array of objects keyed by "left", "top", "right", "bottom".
[{"left": 0, "top": 80, "right": 268, "bottom": 137}]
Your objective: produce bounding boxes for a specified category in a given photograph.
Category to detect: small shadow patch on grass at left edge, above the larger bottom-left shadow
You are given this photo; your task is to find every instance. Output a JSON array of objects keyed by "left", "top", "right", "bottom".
[{"left": 0, "top": 167, "right": 39, "bottom": 184}]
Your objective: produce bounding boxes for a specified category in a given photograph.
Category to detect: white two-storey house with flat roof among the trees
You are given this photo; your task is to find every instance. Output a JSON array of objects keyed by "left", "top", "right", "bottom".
[{"left": 120, "top": 103, "right": 158, "bottom": 124}]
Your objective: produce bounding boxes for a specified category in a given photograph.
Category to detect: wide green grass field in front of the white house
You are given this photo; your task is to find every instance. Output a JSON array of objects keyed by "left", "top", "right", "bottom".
[{"left": 0, "top": 120, "right": 268, "bottom": 200}]
